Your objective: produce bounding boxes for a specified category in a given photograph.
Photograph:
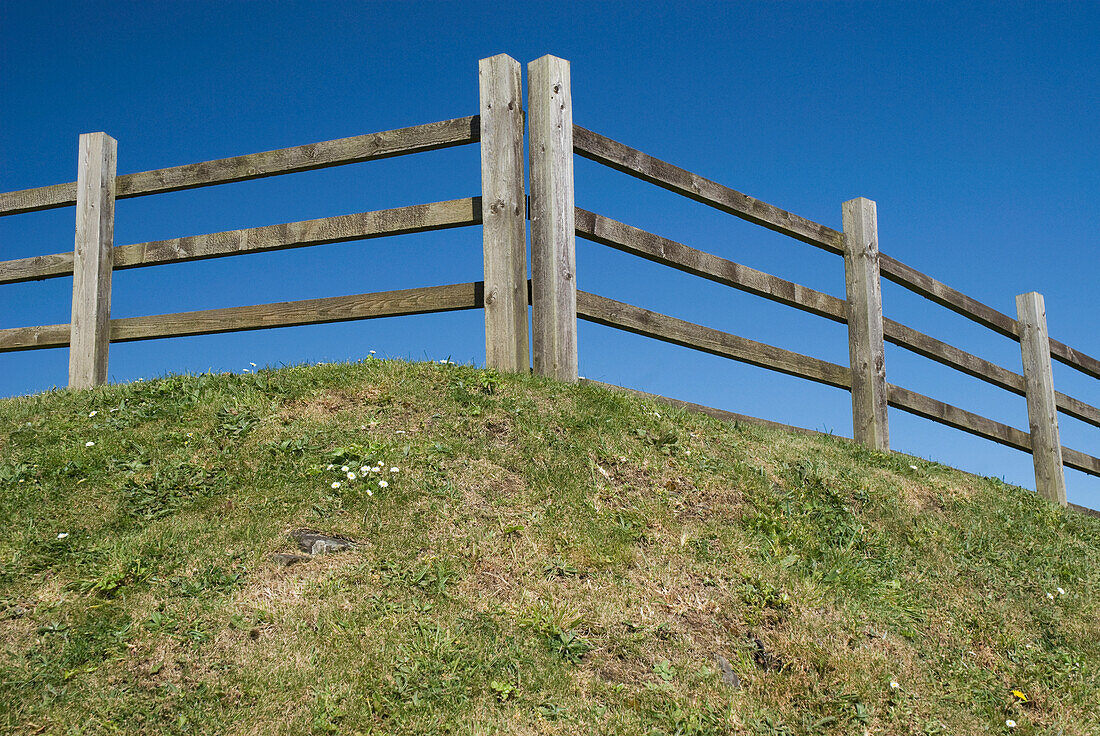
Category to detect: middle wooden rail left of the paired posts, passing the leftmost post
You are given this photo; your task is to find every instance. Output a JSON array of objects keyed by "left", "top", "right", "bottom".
[{"left": 0, "top": 197, "right": 482, "bottom": 284}]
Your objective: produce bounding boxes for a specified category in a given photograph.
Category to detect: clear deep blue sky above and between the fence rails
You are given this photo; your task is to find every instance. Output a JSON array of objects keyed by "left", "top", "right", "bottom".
[{"left": 0, "top": 2, "right": 1100, "bottom": 506}]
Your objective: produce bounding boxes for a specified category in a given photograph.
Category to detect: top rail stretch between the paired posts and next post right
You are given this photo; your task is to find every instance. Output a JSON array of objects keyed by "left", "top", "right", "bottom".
[{"left": 573, "top": 125, "right": 844, "bottom": 254}]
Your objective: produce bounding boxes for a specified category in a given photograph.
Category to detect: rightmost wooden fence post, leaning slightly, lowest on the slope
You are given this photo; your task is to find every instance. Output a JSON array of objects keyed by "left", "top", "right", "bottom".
[{"left": 1016, "top": 292, "right": 1066, "bottom": 506}]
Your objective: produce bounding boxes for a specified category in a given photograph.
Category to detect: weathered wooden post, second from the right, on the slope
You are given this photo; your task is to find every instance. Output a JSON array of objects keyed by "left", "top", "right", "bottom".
[{"left": 844, "top": 197, "right": 890, "bottom": 451}]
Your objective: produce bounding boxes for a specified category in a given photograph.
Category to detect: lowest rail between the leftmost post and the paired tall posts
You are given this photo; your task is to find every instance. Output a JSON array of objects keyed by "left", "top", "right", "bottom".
[{"left": 111, "top": 282, "right": 482, "bottom": 342}]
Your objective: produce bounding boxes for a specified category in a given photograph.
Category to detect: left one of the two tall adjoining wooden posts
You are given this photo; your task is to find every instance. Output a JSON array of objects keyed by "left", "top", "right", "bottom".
[{"left": 477, "top": 54, "right": 531, "bottom": 372}]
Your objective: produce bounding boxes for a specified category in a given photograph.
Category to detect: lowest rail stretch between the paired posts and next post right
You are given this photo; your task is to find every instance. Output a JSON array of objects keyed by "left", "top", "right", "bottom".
[{"left": 576, "top": 292, "right": 851, "bottom": 388}]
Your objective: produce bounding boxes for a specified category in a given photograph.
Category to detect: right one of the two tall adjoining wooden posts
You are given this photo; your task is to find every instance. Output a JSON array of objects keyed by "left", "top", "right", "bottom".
[{"left": 527, "top": 55, "right": 578, "bottom": 382}]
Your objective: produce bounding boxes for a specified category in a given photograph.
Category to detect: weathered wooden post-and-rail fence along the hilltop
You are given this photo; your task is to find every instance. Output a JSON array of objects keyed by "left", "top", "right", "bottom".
[{"left": 0, "top": 55, "right": 1100, "bottom": 505}]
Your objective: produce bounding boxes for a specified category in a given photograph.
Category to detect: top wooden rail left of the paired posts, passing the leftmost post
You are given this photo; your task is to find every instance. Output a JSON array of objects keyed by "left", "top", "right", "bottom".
[{"left": 0, "top": 116, "right": 480, "bottom": 216}]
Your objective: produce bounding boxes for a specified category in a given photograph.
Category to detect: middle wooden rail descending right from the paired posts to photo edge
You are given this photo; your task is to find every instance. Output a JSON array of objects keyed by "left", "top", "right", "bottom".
[{"left": 575, "top": 207, "right": 1100, "bottom": 427}]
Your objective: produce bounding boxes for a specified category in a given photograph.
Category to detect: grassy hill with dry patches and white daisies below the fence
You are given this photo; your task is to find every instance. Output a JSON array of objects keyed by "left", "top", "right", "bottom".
[{"left": 0, "top": 359, "right": 1100, "bottom": 735}]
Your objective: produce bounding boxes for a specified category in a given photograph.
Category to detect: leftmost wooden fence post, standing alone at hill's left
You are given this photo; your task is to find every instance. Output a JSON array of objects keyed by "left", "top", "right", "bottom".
[{"left": 69, "top": 133, "right": 118, "bottom": 388}]
